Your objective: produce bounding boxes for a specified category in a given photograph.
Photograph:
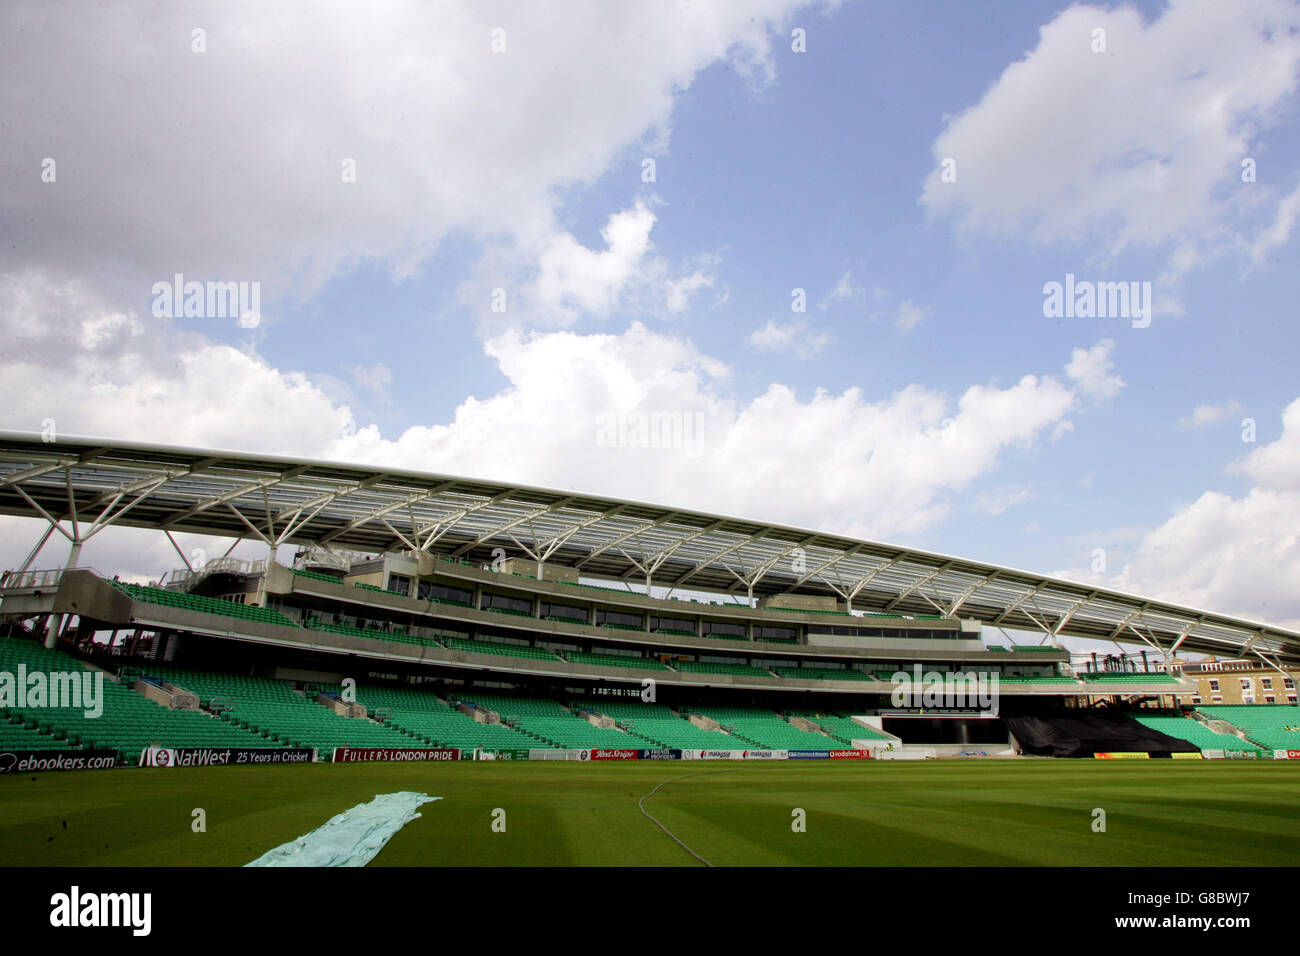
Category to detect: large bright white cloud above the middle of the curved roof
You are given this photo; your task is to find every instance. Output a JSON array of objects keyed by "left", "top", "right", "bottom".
[{"left": 335, "top": 325, "right": 1076, "bottom": 536}]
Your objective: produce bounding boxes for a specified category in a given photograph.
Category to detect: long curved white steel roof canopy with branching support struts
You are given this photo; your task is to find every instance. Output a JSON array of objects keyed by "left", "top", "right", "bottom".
[{"left": 0, "top": 432, "right": 1300, "bottom": 661}]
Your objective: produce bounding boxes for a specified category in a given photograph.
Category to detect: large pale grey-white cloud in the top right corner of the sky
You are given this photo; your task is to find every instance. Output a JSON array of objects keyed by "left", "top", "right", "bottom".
[{"left": 922, "top": 0, "right": 1300, "bottom": 278}]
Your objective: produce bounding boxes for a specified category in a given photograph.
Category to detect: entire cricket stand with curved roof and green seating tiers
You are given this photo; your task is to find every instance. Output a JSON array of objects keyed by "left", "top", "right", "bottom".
[{"left": 0, "top": 434, "right": 1300, "bottom": 773}]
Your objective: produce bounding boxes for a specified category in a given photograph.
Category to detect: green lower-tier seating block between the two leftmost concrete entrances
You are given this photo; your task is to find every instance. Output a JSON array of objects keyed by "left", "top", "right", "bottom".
[{"left": 147, "top": 665, "right": 416, "bottom": 756}]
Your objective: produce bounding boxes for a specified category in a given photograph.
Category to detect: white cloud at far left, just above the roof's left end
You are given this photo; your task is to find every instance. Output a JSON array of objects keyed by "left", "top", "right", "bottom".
[{"left": 0, "top": 274, "right": 351, "bottom": 454}]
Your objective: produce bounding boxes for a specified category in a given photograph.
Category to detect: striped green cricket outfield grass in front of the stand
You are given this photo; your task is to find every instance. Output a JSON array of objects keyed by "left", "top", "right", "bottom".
[{"left": 0, "top": 760, "right": 1300, "bottom": 866}]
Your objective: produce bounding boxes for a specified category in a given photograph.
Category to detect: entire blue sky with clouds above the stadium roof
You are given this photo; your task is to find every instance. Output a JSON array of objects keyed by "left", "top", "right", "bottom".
[{"left": 0, "top": 0, "right": 1300, "bottom": 658}]
